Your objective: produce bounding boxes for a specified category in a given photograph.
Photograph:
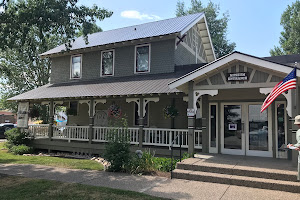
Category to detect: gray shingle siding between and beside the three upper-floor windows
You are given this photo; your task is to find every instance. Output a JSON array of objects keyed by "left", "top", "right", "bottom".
[{"left": 50, "top": 39, "right": 175, "bottom": 83}]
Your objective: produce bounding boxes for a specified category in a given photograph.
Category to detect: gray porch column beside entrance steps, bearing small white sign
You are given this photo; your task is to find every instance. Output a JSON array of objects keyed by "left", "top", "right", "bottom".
[{"left": 188, "top": 81, "right": 195, "bottom": 154}]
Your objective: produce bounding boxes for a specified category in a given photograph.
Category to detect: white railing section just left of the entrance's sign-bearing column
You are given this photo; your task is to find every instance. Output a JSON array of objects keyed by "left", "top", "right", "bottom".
[{"left": 143, "top": 128, "right": 188, "bottom": 148}]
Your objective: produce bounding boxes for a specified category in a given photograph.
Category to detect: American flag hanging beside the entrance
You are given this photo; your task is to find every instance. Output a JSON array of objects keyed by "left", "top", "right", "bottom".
[{"left": 260, "top": 67, "right": 297, "bottom": 113}]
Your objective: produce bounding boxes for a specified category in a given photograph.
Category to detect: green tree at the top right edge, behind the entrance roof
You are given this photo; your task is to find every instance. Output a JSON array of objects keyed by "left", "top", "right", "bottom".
[{"left": 270, "top": 0, "right": 300, "bottom": 56}]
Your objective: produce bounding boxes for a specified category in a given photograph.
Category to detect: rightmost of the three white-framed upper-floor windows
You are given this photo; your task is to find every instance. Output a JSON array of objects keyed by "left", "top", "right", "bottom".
[{"left": 135, "top": 44, "right": 150, "bottom": 73}]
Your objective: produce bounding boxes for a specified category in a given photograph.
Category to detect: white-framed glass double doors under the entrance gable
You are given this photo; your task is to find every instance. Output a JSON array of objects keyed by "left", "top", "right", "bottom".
[{"left": 221, "top": 103, "right": 272, "bottom": 157}]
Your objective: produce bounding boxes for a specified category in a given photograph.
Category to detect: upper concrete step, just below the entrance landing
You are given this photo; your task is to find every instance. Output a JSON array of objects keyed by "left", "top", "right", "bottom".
[{"left": 176, "top": 160, "right": 297, "bottom": 181}]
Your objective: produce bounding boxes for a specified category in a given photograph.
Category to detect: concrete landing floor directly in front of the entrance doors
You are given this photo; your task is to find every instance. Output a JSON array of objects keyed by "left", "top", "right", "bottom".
[{"left": 192, "top": 153, "right": 297, "bottom": 172}]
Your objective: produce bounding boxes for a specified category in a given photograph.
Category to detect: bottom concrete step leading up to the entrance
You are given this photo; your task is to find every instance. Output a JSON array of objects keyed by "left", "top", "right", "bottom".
[{"left": 173, "top": 169, "right": 300, "bottom": 193}]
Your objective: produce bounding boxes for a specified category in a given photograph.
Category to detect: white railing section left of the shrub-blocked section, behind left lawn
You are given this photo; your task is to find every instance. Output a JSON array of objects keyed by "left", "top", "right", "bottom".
[{"left": 52, "top": 126, "right": 89, "bottom": 142}]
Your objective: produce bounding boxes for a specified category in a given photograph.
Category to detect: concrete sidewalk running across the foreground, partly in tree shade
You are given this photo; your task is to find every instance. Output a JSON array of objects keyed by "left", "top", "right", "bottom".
[{"left": 0, "top": 164, "right": 300, "bottom": 200}]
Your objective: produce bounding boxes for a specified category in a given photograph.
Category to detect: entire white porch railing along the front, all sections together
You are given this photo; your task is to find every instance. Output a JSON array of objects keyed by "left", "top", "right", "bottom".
[{"left": 28, "top": 124, "right": 202, "bottom": 149}]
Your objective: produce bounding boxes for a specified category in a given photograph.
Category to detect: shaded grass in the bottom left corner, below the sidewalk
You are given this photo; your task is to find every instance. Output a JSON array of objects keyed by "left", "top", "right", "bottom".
[{"left": 0, "top": 174, "right": 161, "bottom": 200}]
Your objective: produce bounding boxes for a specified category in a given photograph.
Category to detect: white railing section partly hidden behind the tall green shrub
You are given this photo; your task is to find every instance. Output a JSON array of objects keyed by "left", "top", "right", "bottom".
[{"left": 93, "top": 127, "right": 139, "bottom": 144}]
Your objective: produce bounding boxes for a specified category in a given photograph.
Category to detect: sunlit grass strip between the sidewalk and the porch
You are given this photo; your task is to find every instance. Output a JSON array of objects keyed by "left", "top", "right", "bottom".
[{"left": 0, "top": 142, "right": 104, "bottom": 170}]
